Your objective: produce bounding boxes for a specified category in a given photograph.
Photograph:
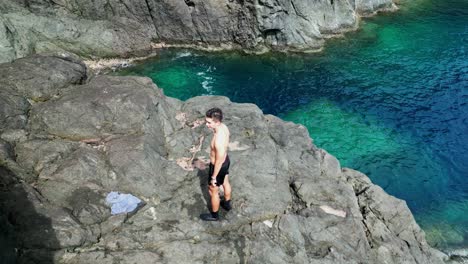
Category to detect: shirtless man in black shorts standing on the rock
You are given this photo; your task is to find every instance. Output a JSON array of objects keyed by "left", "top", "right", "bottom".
[{"left": 200, "top": 108, "right": 231, "bottom": 221}]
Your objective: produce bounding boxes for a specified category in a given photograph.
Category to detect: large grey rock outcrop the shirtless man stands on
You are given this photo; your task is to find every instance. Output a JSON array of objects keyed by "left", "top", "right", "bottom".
[{"left": 0, "top": 56, "right": 450, "bottom": 264}]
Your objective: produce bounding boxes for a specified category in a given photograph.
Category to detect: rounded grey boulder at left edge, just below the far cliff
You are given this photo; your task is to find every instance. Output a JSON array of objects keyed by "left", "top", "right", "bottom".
[{"left": 0, "top": 54, "right": 86, "bottom": 132}]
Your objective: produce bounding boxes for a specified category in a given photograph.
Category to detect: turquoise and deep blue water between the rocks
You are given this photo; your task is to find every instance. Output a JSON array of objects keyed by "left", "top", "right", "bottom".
[{"left": 119, "top": 0, "right": 468, "bottom": 249}]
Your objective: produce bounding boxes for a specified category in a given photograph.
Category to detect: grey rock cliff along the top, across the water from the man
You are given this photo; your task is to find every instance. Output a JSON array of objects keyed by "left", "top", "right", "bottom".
[{"left": 0, "top": 0, "right": 396, "bottom": 62}]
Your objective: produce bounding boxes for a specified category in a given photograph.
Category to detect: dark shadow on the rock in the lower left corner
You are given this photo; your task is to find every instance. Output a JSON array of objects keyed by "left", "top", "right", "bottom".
[{"left": 0, "top": 166, "right": 60, "bottom": 264}]
